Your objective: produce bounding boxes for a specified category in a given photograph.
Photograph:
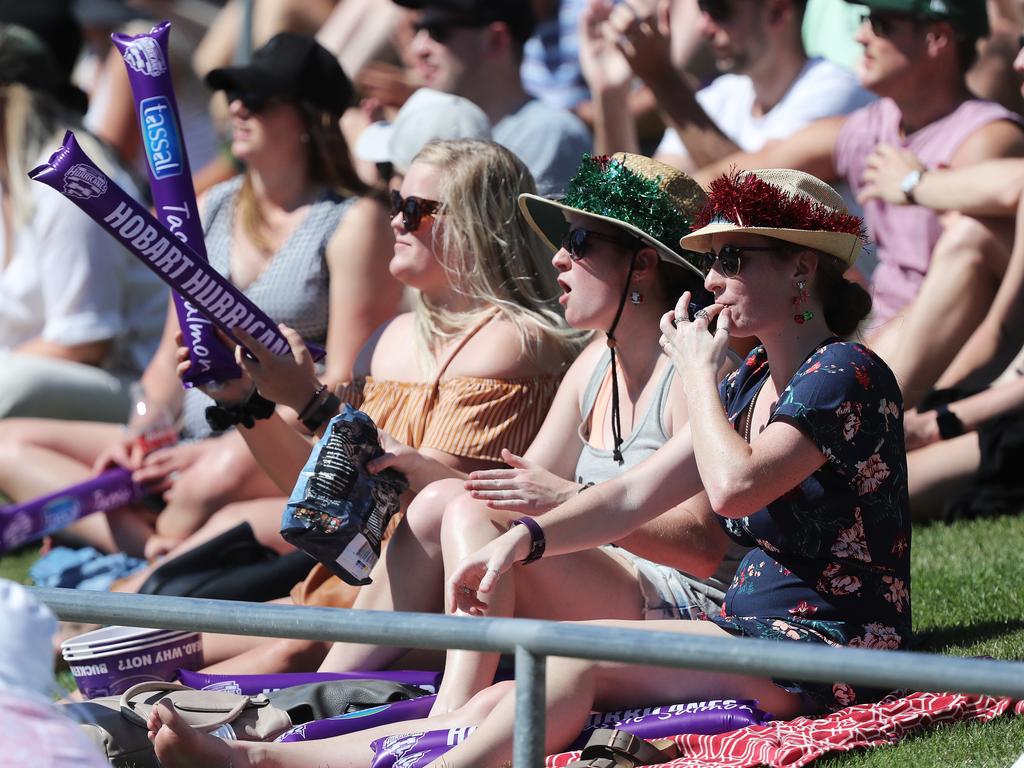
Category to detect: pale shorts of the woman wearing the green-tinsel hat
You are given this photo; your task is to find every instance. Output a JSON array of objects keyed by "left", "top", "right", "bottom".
[{"left": 601, "top": 544, "right": 725, "bottom": 622}]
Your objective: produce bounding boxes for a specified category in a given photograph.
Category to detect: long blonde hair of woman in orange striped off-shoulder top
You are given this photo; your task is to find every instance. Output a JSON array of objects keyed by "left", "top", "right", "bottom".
[{"left": 413, "top": 139, "right": 588, "bottom": 370}]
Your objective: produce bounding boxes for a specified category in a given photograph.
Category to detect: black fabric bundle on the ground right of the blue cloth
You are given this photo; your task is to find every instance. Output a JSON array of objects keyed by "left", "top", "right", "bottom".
[{"left": 139, "top": 522, "right": 312, "bottom": 602}]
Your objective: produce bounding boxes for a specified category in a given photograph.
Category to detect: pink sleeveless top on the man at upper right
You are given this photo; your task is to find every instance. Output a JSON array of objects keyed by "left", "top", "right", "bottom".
[{"left": 836, "top": 98, "right": 1021, "bottom": 323}]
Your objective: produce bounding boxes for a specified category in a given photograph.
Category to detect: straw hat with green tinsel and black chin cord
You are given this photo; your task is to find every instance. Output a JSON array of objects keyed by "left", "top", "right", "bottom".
[{"left": 519, "top": 152, "right": 708, "bottom": 278}]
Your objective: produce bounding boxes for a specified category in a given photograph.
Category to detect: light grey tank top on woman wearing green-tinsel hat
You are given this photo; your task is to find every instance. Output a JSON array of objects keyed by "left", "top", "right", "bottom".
[{"left": 575, "top": 350, "right": 675, "bottom": 484}]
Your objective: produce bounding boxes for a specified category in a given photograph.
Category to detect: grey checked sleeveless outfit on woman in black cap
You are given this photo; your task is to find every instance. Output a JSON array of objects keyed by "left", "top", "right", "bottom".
[{"left": 181, "top": 176, "right": 356, "bottom": 439}]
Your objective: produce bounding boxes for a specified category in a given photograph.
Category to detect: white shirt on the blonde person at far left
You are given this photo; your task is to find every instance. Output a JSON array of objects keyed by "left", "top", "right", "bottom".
[{"left": 0, "top": 136, "right": 167, "bottom": 382}]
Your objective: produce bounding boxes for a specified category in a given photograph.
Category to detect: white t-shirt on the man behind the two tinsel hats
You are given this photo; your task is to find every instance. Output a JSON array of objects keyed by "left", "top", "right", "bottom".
[{"left": 655, "top": 58, "right": 874, "bottom": 156}]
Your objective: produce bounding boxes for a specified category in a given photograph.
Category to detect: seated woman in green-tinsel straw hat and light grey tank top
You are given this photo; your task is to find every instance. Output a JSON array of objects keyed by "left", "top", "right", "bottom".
[{"left": 307, "top": 155, "right": 731, "bottom": 712}]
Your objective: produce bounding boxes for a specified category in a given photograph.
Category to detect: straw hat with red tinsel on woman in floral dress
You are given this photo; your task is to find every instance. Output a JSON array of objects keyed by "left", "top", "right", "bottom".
[{"left": 680, "top": 169, "right": 864, "bottom": 265}]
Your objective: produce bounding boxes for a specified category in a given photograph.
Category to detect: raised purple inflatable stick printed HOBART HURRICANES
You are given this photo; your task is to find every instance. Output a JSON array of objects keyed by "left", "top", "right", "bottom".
[{"left": 29, "top": 131, "right": 324, "bottom": 360}]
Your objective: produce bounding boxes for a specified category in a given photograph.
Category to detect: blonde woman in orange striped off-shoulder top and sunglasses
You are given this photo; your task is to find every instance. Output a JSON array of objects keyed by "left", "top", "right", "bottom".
[{"left": 153, "top": 139, "right": 583, "bottom": 671}]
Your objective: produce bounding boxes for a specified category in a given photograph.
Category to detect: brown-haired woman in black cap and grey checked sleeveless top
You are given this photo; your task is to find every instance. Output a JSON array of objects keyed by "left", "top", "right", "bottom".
[{"left": 0, "top": 35, "right": 401, "bottom": 559}]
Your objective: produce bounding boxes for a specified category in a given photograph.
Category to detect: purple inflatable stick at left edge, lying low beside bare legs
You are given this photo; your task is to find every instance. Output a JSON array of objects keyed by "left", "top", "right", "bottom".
[{"left": 0, "top": 467, "right": 145, "bottom": 554}]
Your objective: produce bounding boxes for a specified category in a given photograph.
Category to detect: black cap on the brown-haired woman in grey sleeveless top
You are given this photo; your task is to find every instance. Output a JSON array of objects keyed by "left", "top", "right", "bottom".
[{"left": 206, "top": 32, "right": 354, "bottom": 115}]
